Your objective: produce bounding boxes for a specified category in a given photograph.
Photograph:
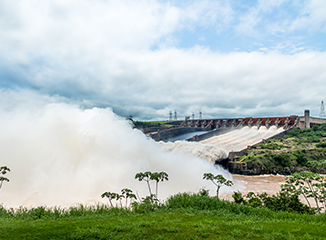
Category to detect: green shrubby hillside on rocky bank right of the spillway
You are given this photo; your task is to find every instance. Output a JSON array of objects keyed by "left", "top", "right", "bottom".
[{"left": 239, "top": 124, "right": 326, "bottom": 174}]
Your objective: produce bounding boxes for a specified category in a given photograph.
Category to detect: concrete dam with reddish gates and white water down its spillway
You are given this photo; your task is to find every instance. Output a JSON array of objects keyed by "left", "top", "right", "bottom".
[{"left": 148, "top": 110, "right": 326, "bottom": 174}]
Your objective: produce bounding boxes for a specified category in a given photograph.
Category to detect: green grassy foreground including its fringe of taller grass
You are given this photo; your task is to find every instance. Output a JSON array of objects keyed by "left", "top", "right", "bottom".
[{"left": 0, "top": 197, "right": 326, "bottom": 239}]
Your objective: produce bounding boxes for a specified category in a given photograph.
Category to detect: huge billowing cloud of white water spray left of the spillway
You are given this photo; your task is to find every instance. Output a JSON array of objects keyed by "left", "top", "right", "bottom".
[{"left": 0, "top": 99, "right": 232, "bottom": 207}]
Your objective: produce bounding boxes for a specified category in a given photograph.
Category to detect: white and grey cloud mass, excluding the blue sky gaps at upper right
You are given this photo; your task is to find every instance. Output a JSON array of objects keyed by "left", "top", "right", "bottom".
[{"left": 0, "top": 0, "right": 326, "bottom": 118}]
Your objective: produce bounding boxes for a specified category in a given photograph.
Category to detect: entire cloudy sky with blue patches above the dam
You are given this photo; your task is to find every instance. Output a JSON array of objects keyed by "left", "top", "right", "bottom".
[{"left": 0, "top": 0, "right": 326, "bottom": 120}]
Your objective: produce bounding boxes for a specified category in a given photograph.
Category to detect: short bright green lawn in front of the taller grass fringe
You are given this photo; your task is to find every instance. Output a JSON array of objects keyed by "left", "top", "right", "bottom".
[{"left": 0, "top": 211, "right": 326, "bottom": 240}]
